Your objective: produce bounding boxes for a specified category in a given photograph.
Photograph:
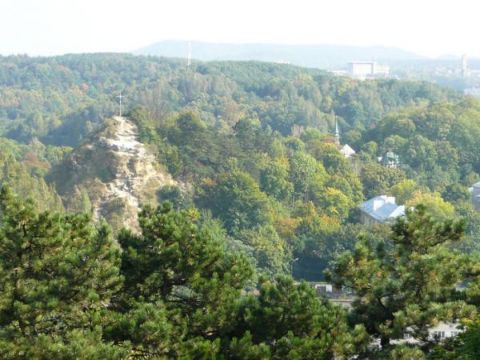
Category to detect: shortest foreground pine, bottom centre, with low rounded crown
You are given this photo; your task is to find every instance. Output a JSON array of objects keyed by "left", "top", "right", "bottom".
[{"left": 231, "top": 276, "right": 367, "bottom": 360}]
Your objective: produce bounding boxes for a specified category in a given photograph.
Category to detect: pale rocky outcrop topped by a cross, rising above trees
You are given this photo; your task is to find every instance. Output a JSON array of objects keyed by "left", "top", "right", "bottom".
[{"left": 51, "top": 116, "right": 178, "bottom": 230}]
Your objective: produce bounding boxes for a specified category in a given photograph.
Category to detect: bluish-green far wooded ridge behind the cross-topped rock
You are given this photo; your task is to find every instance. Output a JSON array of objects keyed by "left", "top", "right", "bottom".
[{"left": 0, "top": 54, "right": 457, "bottom": 145}]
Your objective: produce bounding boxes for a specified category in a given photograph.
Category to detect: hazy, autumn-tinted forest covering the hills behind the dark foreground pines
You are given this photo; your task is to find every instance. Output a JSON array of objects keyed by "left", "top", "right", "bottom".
[{"left": 0, "top": 54, "right": 480, "bottom": 279}]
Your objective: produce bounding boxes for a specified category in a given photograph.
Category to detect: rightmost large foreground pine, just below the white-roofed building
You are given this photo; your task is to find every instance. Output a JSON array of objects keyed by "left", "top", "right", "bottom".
[{"left": 328, "top": 205, "right": 473, "bottom": 350}]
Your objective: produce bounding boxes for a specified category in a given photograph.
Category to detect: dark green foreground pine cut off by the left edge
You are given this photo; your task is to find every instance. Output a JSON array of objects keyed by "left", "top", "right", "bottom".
[{"left": 0, "top": 187, "right": 121, "bottom": 359}]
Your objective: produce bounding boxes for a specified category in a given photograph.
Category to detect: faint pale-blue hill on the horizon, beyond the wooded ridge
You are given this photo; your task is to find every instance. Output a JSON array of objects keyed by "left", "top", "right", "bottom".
[{"left": 133, "top": 40, "right": 422, "bottom": 69}]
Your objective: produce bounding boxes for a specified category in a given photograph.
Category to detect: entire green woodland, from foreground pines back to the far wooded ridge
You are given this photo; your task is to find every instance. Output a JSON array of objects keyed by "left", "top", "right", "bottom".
[{"left": 0, "top": 54, "right": 480, "bottom": 359}]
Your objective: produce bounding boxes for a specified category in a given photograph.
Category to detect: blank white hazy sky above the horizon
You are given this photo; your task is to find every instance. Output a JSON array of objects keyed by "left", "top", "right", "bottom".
[{"left": 0, "top": 0, "right": 480, "bottom": 56}]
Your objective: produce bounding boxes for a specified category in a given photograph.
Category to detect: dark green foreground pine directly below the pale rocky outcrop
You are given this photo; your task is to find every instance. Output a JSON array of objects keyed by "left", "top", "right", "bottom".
[{"left": 110, "top": 203, "right": 253, "bottom": 358}]
